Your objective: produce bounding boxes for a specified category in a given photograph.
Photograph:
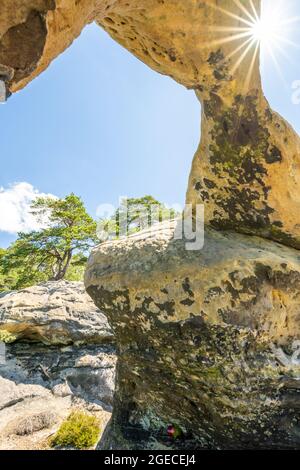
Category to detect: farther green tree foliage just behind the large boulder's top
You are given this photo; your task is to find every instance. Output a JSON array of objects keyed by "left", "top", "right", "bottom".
[{"left": 98, "top": 196, "right": 178, "bottom": 240}]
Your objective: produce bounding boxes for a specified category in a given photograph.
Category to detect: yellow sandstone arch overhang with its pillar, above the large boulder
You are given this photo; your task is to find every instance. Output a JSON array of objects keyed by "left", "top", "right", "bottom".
[{"left": 0, "top": 0, "right": 300, "bottom": 248}]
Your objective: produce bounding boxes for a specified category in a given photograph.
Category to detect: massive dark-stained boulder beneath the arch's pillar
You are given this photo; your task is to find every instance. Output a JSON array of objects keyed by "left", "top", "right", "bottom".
[{"left": 85, "top": 225, "right": 300, "bottom": 449}]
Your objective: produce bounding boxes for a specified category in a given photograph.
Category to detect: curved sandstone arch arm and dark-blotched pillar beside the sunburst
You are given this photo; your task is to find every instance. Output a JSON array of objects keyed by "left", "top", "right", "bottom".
[{"left": 98, "top": 0, "right": 300, "bottom": 248}]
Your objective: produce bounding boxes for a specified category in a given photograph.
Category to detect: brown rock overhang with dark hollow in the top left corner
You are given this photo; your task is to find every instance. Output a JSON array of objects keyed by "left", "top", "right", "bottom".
[{"left": 0, "top": 0, "right": 103, "bottom": 92}]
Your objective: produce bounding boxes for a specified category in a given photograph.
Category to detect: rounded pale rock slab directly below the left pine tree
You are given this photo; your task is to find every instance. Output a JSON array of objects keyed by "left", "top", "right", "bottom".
[{"left": 0, "top": 281, "right": 113, "bottom": 344}]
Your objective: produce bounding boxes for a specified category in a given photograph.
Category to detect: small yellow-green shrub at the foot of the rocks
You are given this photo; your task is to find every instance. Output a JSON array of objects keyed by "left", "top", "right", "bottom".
[{"left": 50, "top": 411, "right": 100, "bottom": 449}]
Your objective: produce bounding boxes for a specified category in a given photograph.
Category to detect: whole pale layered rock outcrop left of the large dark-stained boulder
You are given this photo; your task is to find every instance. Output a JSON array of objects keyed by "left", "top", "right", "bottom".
[{"left": 0, "top": 282, "right": 116, "bottom": 449}]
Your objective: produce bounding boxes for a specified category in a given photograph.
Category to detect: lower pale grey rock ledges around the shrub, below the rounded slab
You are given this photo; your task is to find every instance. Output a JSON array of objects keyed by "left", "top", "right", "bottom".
[{"left": 0, "top": 343, "right": 116, "bottom": 450}]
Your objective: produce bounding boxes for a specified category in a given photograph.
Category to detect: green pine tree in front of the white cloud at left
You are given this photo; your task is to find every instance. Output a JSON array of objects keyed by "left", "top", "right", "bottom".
[{"left": 0, "top": 194, "right": 96, "bottom": 290}]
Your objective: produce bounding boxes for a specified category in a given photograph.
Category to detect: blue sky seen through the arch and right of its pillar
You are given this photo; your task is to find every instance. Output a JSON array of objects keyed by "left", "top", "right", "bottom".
[{"left": 0, "top": 0, "right": 300, "bottom": 246}]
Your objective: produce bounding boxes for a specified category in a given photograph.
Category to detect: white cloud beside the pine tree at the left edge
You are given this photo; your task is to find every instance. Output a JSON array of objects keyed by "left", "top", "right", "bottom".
[{"left": 0, "top": 182, "right": 55, "bottom": 234}]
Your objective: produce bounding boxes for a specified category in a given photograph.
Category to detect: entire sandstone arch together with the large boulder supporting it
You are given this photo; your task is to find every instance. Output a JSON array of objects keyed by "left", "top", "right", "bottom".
[{"left": 0, "top": 0, "right": 300, "bottom": 448}]
